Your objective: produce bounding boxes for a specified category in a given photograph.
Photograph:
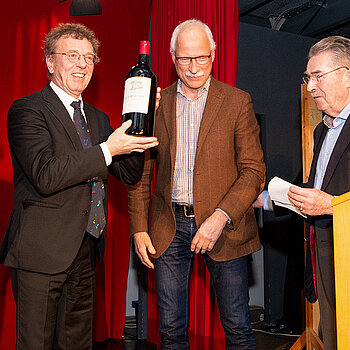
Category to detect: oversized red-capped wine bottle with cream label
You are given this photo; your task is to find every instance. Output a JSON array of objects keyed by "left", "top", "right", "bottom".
[{"left": 122, "top": 41, "right": 157, "bottom": 136}]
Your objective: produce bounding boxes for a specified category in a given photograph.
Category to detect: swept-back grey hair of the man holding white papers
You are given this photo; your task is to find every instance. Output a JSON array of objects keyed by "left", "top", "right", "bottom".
[{"left": 308, "top": 36, "right": 350, "bottom": 68}]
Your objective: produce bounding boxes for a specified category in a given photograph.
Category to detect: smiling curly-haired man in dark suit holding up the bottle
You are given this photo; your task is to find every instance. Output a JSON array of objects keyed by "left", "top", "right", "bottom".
[{"left": 0, "top": 24, "right": 158, "bottom": 350}]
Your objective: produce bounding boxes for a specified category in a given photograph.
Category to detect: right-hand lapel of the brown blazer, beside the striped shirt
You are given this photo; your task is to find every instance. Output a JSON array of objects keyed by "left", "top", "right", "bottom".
[{"left": 197, "top": 77, "right": 224, "bottom": 152}]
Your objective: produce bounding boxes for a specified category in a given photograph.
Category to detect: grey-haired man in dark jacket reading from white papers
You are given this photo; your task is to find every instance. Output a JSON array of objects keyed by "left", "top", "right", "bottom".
[{"left": 288, "top": 36, "right": 350, "bottom": 350}]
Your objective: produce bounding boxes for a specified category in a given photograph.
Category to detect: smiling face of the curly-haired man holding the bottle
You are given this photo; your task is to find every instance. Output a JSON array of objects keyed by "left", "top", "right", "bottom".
[{"left": 46, "top": 36, "right": 94, "bottom": 98}]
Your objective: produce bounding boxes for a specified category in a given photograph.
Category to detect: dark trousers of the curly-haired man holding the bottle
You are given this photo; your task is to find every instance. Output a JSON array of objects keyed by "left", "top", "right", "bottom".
[{"left": 11, "top": 234, "right": 96, "bottom": 350}]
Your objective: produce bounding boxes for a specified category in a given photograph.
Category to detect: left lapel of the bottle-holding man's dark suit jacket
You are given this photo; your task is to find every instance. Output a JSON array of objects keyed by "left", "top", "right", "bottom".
[{"left": 42, "top": 85, "right": 83, "bottom": 150}]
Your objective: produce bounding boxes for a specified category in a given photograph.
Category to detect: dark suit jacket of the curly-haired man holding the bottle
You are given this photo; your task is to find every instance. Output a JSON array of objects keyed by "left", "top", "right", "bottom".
[{"left": 0, "top": 85, "right": 144, "bottom": 274}]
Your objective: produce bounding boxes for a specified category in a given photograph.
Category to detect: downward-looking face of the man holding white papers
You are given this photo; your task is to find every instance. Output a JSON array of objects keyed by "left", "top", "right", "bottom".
[{"left": 305, "top": 51, "right": 350, "bottom": 118}]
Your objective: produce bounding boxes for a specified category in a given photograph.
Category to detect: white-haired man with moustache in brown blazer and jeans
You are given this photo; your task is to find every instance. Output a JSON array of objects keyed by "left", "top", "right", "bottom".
[{"left": 129, "top": 20, "right": 265, "bottom": 349}]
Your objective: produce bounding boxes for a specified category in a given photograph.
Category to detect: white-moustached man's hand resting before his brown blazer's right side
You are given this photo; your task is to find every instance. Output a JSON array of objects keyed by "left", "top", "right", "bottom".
[{"left": 191, "top": 210, "right": 227, "bottom": 254}]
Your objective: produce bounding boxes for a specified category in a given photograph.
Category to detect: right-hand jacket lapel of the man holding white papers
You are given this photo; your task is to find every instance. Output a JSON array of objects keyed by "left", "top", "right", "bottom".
[{"left": 322, "top": 117, "right": 350, "bottom": 190}]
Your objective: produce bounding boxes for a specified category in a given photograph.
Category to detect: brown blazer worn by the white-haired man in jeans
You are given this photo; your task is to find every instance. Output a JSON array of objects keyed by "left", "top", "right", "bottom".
[{"left": 129, "top": 78, "right": 265, "bottom": 261}]
